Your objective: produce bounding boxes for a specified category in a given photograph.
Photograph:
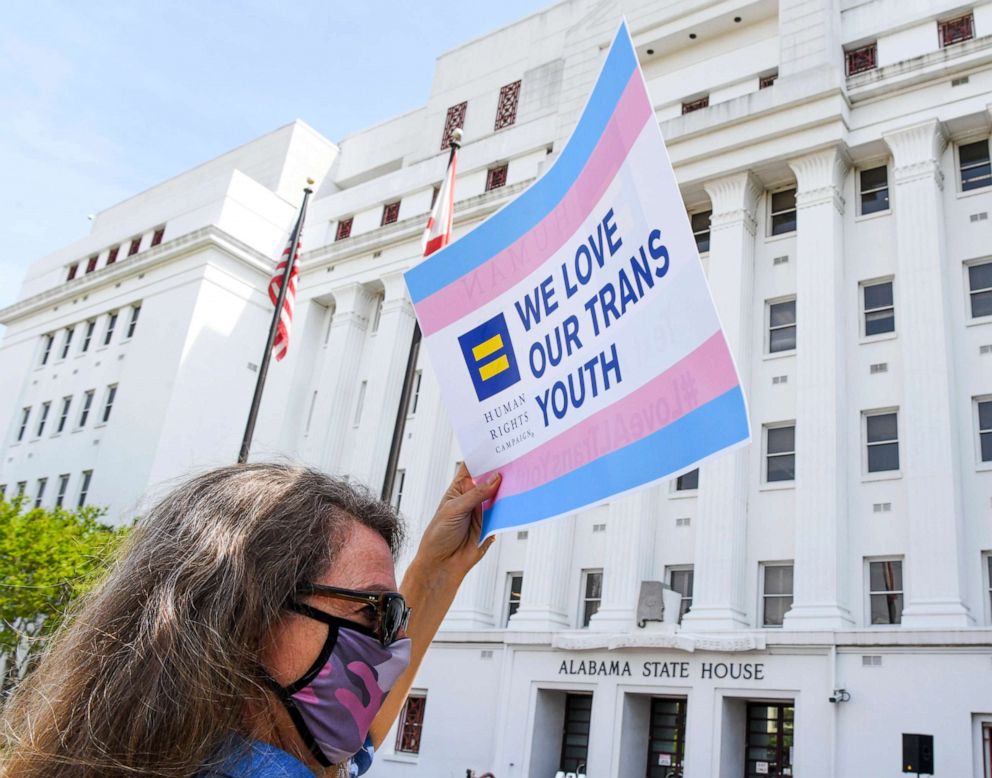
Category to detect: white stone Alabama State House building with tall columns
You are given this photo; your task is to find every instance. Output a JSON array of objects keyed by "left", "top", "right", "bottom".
[{"left": 0, "top": 0, "right": 992, "bottom": 778}]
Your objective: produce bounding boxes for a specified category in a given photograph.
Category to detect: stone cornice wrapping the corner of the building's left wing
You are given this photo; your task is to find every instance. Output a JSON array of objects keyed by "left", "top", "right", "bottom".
[{"left": 0, "top": 225, "right": 275, "bottom": 325}]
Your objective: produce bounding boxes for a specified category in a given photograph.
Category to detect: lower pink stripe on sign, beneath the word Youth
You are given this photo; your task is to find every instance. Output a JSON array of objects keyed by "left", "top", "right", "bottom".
[{"left": 475, "top": 331, "right": 737, "bottom": 500}]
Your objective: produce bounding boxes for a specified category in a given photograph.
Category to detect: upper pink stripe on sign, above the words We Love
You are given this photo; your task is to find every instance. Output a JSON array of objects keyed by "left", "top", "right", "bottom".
[{"left": 416, "top": 70, "right": 652, "bottom": 335}]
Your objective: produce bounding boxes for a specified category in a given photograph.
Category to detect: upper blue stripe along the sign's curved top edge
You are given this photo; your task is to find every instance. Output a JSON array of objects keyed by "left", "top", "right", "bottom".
[{"left": 406, "top": 23, "right": 637, "bottom": 303}]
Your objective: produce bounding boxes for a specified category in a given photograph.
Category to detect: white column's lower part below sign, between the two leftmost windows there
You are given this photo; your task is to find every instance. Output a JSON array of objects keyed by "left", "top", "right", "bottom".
[{"left": 510, "top": 517, "right": 575, "bottom": 632}]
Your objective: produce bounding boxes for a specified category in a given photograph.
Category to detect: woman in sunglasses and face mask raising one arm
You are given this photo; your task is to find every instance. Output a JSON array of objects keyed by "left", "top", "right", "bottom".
[{"left": 0, "top": 464, "right": 499, "bottom": 778}]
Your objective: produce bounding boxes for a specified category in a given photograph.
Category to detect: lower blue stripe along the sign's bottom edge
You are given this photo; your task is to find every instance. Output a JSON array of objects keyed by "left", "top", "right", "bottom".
[{"left": 482, "top": 386, "right": 748, "bottom": 537}]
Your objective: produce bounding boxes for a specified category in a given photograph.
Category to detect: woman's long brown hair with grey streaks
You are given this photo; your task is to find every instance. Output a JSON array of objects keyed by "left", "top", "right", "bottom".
[{"left": 0, "top": 464, "right": 402, "bottom": 778}]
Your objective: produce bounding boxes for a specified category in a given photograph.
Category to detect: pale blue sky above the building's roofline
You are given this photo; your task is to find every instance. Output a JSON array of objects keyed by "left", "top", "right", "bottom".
[{"left": 0, "top": 0, "right": 552, "bottom": 307}]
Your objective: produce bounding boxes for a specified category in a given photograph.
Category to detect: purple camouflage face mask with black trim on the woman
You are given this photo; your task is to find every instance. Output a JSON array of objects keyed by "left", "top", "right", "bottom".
[{"left": 283, "top": 619, "right": 412, "bottom": 766}]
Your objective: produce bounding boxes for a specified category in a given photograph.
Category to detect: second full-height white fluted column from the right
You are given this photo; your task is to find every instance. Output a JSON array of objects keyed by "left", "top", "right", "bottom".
[{"left": 785, "top": 146, "right": 852, "bottom": 629}]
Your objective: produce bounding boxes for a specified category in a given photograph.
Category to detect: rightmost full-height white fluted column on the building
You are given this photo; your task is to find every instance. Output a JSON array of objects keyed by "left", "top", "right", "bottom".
[{"left": 880, "top": 120, "right": 972, "bottom": 629}]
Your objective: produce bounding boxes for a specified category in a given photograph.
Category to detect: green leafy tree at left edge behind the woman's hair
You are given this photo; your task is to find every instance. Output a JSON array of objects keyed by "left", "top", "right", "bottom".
[{"left": 0, "top": 497, "right": 127, "bottom": 692}]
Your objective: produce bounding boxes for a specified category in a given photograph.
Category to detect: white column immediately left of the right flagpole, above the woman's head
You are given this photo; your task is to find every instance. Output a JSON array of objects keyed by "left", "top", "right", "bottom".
[{"left": 351, "top": 271, "right": 416, "bottom": 493}]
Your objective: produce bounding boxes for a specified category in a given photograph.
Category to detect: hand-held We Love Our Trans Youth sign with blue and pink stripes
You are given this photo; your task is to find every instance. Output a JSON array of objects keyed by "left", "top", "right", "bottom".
[{"left": 406, "top": 24, "right": 750, "bottom": 535}]
